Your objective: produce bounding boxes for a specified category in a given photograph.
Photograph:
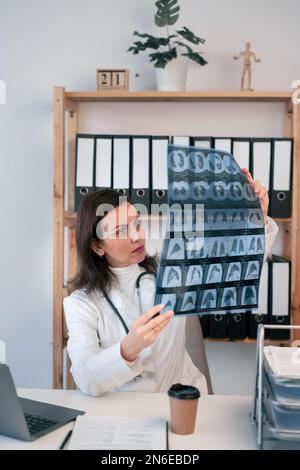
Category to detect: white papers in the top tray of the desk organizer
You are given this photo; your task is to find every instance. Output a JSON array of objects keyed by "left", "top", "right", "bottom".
[{"left": 264, "top": 346, "right": 300, "bottom": 379}]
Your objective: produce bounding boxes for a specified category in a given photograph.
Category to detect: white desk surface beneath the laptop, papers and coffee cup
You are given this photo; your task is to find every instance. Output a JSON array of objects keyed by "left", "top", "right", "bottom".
[{"left": 0, "top": 389, "right": 257, "bottom": 450}]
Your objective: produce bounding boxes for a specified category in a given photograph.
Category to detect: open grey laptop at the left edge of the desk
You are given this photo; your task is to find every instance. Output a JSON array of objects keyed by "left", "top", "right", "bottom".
[{"left": 0, "top": 363, "right": 84, "bottom": 441}]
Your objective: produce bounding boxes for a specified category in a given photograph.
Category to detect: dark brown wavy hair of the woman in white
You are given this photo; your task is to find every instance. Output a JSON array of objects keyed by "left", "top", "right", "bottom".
[{"left": 68, "top": 189, "right": 158, "bottom": 293}]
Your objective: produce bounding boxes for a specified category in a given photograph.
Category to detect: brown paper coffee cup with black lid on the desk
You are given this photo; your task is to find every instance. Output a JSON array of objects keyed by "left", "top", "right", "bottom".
[{"left": 168, "top": 383, "right": 200, "bottom": 434}]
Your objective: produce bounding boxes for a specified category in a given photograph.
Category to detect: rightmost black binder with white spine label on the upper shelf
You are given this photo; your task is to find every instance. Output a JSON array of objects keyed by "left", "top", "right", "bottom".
[{"left": 270, "top": 138, "right": 293, "bottom": 218}]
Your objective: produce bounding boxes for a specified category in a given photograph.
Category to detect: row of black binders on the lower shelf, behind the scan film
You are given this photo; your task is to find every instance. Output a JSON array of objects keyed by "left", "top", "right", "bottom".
[{"left": 199, "top": 255, "right": 291, "bottom": 340}]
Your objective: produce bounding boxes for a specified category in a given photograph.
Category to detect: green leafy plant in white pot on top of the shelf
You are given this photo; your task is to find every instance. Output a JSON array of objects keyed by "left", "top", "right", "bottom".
[{"left": 128, "top": 0, "right": 207, "bottom": 91}]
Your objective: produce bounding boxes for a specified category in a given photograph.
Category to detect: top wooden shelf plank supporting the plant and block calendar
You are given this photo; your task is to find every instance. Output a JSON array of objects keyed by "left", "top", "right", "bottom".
[{"left": 65, "top": 90, "right": 291, "bottom": 103}]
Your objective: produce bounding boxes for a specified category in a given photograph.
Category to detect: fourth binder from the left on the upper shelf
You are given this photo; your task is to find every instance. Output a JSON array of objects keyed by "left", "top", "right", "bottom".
[{"left": 131, "top": 135, "right": 151, "bottom": 209}]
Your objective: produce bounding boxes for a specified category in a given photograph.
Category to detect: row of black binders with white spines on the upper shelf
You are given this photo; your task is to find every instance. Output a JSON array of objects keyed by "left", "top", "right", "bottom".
[{"left": 74, "top": 134, "right": 293, "bottom": 218}]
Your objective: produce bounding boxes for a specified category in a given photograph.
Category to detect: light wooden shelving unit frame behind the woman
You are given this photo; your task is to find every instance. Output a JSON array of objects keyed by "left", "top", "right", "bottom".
[{"left": 53, "top": 87, "right": 300, "bottom": 388}]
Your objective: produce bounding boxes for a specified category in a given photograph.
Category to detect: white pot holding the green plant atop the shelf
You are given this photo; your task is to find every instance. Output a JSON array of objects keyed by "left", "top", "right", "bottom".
[{"left": 155, "top": 56, "right": 188, "bottom": 91}]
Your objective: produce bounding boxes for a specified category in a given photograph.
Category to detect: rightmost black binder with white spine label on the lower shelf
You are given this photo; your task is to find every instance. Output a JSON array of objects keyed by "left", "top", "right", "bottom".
[{"left": 269, "top": 255, "right": 291, "bottom": 339}]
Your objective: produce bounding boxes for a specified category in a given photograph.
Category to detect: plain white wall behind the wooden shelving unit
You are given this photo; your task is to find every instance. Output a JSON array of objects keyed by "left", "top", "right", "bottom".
[{"left": 0, "top": 0, "right": 300, "bottom": 393}]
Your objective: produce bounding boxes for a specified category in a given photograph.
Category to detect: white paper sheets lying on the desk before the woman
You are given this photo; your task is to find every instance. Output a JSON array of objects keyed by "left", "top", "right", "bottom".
[{"left": 68, "top": 415, "right": 168, "bottom": 450}]
